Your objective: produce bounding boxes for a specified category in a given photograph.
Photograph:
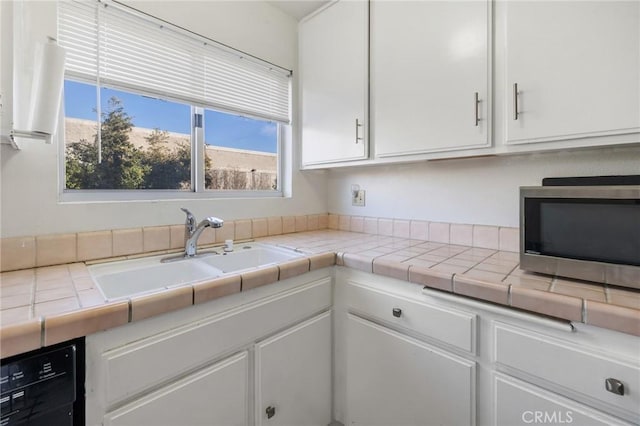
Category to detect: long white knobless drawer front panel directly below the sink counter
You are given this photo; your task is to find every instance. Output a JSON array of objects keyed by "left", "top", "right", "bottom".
[{"left": 100, "top": 278, "right": 332, "bottom": 406}]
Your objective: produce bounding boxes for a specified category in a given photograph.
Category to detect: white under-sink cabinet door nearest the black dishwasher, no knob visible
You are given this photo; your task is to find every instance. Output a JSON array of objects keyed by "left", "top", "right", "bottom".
[{"left": 104, "top": 351, "right": 249, "bottom": 426}]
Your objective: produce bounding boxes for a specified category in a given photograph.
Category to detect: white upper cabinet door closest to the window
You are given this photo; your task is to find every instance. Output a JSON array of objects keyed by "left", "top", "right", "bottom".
[{"left": 299, "top": 1, "right": 369, "bottom": 165}]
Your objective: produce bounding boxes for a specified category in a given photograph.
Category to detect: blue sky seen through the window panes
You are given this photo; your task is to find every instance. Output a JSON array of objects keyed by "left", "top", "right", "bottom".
[{"left": 64, "top": 80, "right": 277, "bottom": 152}]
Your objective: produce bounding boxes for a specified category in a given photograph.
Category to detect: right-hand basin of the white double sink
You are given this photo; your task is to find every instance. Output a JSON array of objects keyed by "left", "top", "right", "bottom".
[{"left": 198, "top": 243, "right": 304, "bottom": 273}]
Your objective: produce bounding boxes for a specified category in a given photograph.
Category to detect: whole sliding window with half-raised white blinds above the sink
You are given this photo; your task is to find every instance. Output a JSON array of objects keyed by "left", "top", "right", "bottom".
[{"left": 58, "top": 1, "right": 291, "bottom": 196}]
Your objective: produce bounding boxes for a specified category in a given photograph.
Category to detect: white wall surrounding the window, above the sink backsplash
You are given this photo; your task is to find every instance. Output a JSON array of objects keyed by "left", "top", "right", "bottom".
[{"left": 0, "top": 1, "right": 327, "bottom": 237}]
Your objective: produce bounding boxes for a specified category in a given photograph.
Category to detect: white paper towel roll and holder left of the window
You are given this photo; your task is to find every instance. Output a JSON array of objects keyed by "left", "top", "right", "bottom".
[{"left": 8, "top": 37, "right": 65, "bottom": 150}]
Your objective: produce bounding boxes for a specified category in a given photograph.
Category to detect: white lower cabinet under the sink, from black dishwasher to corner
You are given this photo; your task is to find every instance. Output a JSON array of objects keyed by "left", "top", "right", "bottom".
[{"left": 85, "top": 269, "right": 333, "bottom": 426}]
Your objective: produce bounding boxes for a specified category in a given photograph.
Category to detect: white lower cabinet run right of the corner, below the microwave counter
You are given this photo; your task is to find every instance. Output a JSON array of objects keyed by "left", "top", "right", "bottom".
[{"left": 334, "top": 267, "right": 640, "bottom": 426}]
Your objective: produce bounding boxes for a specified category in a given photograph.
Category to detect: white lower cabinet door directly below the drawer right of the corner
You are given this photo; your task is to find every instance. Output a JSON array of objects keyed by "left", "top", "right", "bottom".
[{"left": 345, "top": 315, "right": 476, "bottom": 426}]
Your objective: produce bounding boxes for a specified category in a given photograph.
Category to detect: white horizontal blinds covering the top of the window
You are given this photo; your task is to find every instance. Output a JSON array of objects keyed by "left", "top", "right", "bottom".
[{"left": 58, "top": 1, "right": 291, "bottom": 123}]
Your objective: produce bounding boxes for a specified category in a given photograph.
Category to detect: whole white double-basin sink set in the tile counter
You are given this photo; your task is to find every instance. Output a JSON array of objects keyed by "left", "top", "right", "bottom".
[{"left": 88, "top": 243, "right": 304, "bottom": 300}]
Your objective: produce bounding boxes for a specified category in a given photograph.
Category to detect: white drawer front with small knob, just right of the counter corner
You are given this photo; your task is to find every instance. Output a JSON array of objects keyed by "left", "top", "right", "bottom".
[{"left": 346, "top": 281, "right": 476, "bottom": 353}]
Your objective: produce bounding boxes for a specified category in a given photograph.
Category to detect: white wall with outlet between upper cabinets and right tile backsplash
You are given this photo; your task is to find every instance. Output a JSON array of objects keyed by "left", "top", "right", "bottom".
[{"left": 328, "top": 146, "right": 640, "bottom": 227}]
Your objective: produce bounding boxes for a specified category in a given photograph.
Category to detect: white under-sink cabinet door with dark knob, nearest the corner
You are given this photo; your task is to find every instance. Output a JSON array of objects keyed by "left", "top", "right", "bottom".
[{"left": 255, "top": 312, "right": 332, "bottom": 426}]
